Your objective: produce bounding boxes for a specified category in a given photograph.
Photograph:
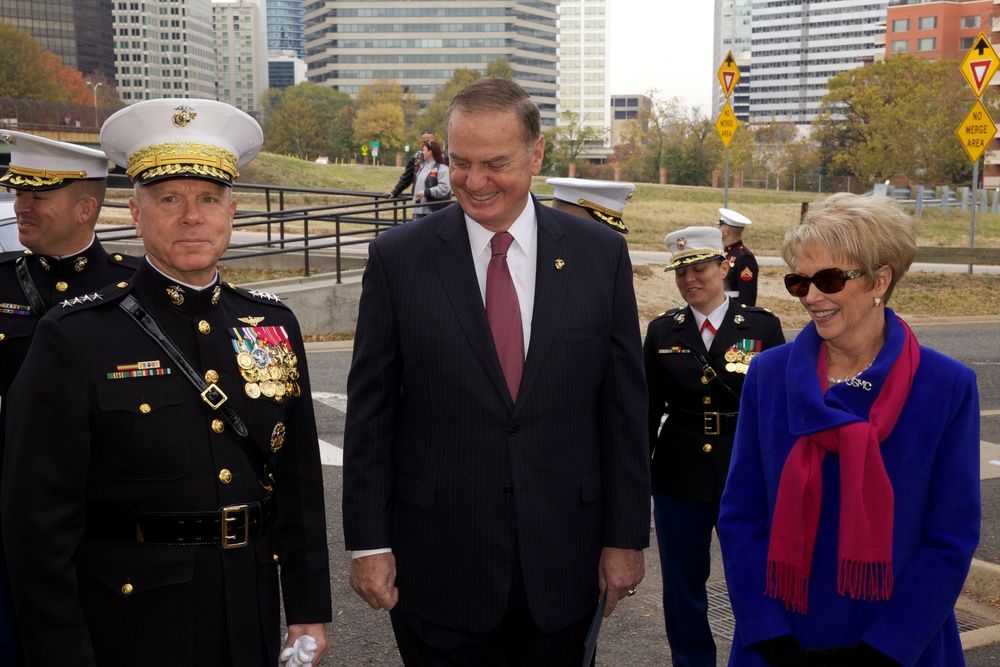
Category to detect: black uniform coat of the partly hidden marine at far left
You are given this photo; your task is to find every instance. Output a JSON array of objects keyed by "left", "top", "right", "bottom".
[{"left": 0, "top": 238, "right": 139, "bottom": 456}]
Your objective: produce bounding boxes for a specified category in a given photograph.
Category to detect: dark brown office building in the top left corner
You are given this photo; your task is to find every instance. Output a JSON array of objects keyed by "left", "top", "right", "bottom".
[{"left": 0, "top": 0, "right": 115, "bottom": 80}]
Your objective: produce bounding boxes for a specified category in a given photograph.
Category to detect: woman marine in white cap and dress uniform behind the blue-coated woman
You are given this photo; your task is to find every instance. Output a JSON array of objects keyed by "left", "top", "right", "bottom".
[{"left": 643, "top": 227, "right": 785, "bottom": 667}]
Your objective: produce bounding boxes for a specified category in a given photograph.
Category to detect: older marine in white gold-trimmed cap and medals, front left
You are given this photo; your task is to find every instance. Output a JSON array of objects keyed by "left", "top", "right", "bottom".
[{"left": 2, "top": 99, "right": 331, "bottom": 667}]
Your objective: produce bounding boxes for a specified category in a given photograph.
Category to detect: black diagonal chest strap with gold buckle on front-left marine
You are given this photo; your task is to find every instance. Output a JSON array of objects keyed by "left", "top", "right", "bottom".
[{"left": 119, "top": 294, "right": 275, "bottom": 492}]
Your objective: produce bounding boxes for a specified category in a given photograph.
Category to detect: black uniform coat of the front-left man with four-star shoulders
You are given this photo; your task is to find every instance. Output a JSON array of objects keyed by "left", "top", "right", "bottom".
[{"left": 2, "top": 262, "right": 331, "bottom": 667}]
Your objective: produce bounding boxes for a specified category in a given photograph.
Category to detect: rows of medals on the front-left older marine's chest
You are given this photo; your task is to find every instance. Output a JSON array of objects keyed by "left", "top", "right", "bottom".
[{"left": 232, "top": 327, "right": 302, "bottom": 402}]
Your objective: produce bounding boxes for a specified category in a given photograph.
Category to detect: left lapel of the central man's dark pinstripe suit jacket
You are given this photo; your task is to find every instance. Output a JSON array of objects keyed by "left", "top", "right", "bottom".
[{"left": 434, "top": 211, "right": 510, "bottom": 402}]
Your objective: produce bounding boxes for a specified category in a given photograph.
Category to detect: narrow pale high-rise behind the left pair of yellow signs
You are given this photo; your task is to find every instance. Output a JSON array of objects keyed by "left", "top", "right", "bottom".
[{"left": 704, "top": 0, "right": 754, "bottom": 122}]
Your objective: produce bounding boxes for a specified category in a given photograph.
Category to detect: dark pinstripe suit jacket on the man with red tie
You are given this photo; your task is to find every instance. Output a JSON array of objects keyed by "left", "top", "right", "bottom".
[{"left": 344, "top": 198, "right": 650, "bottom": 632}]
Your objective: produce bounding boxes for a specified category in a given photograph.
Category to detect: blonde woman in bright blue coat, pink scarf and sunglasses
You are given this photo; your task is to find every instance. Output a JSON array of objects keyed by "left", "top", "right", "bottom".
[{"left": 718, "top": 194, "right": 980, "bottom": 667}]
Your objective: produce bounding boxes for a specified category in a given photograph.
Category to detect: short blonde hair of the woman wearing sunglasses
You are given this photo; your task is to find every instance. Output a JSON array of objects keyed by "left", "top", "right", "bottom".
[{"left": 781, "top": 192, "right": 917, "bottom": 302}]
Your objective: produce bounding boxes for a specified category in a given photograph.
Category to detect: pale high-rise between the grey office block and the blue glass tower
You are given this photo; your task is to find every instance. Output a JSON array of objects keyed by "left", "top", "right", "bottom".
[{"left": 212, "top": 0, "right": 269, "bottom": 113}]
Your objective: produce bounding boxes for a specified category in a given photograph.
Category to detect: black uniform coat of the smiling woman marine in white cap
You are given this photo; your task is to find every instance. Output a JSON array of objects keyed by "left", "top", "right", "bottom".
[{"left": 643, "top": 299, "right": 785, "bottom": 502}]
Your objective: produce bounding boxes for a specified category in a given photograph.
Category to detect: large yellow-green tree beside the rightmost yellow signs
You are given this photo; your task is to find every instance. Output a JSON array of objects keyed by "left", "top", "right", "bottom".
[{"left": 814, "top": 54, "right": 971, "bottom": 187}]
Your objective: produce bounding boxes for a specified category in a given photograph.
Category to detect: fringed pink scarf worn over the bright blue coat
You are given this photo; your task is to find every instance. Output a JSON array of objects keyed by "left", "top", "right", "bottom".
[{"left": 765, "top": 320, "right": 920, "bottom": 614}]
